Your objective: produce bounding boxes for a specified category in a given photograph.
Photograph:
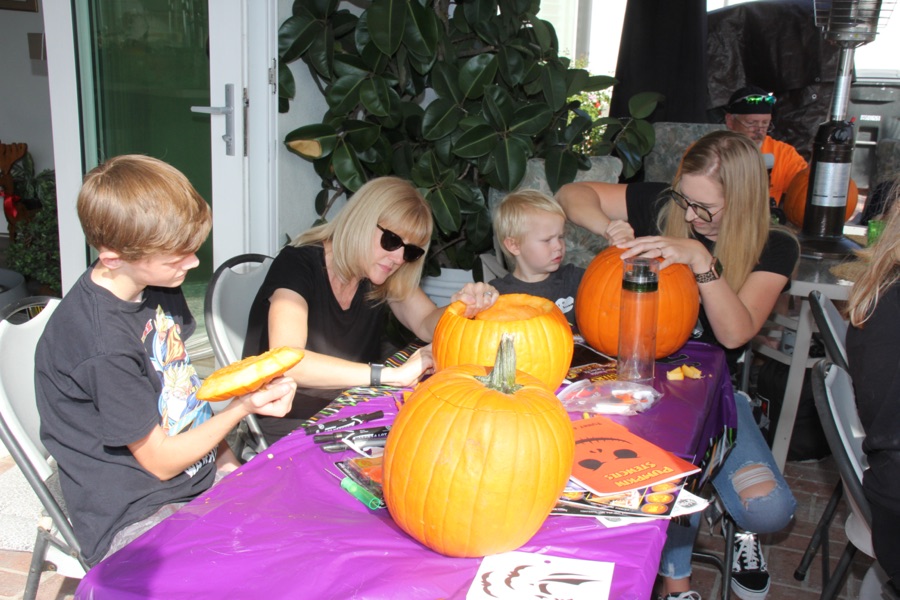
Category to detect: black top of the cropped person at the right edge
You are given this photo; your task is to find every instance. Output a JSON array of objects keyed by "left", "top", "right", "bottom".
[{"left": 847, "top": 283, "right": 900, "bottom": 512}]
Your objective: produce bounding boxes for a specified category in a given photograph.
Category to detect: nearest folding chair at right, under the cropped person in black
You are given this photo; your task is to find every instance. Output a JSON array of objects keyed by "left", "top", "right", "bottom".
[{"left": 812, "top": 359, "right": 875, "bottom": 600}]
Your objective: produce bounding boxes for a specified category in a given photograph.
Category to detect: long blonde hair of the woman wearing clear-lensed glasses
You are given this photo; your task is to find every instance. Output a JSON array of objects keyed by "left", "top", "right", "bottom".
[{"left": 658, "top": 130, "right": 796, "bottom": 292}]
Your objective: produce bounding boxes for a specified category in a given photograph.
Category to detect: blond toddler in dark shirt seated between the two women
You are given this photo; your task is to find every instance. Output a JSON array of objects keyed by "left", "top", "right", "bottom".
[{"left": 491, "top": 190, "right": 584, "bottom": 325}]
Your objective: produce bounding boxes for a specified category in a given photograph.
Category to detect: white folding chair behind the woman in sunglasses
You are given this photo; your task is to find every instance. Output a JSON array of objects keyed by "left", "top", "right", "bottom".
[{"left": 203, "top": 254, "right": 273, "bottom": 454}]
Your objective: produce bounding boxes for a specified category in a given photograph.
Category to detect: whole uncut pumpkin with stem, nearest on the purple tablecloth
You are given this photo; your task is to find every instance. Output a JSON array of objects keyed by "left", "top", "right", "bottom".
[{"left": 383, "top": 339, "right": 575, "bottom": 557}]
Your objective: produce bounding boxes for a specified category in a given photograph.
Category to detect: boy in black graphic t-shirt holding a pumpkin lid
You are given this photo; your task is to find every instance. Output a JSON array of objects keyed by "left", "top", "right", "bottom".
[{"left": 35, "top": 155, "right": 296, "bottom": 565}]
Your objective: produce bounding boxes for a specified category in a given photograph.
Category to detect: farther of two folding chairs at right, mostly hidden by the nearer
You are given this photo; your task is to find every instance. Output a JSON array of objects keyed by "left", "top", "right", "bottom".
[{"left": 794, "top": 290, "right": 848, "bottom": 581}]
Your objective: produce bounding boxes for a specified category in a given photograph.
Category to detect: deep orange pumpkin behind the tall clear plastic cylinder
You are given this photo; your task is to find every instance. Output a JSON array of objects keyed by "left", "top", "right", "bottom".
[{"left": 575, "top": 246, "right": 700, "bottom": 358}]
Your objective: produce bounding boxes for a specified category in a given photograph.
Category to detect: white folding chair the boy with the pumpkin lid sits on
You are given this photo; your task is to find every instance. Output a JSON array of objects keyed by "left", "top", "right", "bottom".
[{"left": 0, "top": 296, "right": 88, "bottom": 600}]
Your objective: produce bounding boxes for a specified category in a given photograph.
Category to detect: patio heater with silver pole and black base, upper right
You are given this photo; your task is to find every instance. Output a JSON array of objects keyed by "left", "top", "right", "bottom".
[{"left": 800, "top": 0, "right": 894, "bottom": 258}]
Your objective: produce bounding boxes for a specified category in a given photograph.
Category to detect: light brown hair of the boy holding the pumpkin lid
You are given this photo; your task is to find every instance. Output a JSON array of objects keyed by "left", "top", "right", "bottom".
[{"left": 77, "top": 154, "right": 212, "bottom": 261}]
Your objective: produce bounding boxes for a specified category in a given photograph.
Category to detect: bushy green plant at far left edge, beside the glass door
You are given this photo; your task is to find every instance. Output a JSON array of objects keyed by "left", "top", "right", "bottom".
[{"left": 7, "top": 154, "right": 62, "bottom": 296}]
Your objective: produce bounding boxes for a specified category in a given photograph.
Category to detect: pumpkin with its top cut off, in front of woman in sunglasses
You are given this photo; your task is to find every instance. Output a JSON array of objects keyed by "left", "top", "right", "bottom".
[{"left": 432, "top": 294, "right": 574, "bottom": 391}]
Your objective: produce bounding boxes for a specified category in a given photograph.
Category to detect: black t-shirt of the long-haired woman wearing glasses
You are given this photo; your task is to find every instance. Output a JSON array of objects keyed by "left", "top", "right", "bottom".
[{"left": 625, "top": 183, "right": 800, "bottom": 373}]
